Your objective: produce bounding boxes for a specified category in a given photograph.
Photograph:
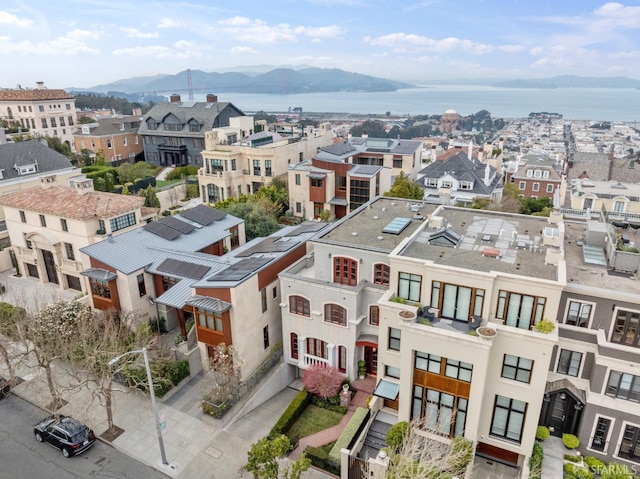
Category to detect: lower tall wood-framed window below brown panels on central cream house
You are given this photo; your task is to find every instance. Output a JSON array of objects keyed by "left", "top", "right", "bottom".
[{"left": 411, "top": 384, "right": 468, "bottom": 437}]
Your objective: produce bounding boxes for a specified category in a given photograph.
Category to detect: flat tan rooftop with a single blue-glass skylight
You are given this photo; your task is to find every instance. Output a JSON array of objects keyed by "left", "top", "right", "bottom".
[{"left": 315, "top": 197, "right": 440, "bottom": 253}]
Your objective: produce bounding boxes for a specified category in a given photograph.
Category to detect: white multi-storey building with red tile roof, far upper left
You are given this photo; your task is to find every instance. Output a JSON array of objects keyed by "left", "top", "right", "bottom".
[{"left": 0, "top": 82, "right": 77, "bottom": 151}]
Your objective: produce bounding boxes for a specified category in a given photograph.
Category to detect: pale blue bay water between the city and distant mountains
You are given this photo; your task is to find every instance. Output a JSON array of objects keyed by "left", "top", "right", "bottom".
[{"left": 194, "top": 85, "right": 640, "bottom": 121}]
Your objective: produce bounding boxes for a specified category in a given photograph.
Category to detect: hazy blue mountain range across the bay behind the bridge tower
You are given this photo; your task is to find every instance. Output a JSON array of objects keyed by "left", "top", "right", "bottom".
[{"left": 77, "top": 67, "right": 413, "bottom": 95}]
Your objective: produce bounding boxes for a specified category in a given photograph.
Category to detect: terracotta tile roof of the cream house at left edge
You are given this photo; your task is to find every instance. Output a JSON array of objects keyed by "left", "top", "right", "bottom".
[{"left": 0, "top": 186, "right": 144, "bottom": 220}]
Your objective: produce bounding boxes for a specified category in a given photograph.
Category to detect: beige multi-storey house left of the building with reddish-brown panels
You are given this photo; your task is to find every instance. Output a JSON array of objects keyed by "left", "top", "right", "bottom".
[{"left": 198, "top": 122, "right": 334, "bottom": 203}]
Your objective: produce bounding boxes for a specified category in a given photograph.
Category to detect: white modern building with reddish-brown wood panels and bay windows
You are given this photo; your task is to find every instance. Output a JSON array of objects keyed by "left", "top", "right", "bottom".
[{"left": 288, "top": 137, "right": 422, "bottom": 218}]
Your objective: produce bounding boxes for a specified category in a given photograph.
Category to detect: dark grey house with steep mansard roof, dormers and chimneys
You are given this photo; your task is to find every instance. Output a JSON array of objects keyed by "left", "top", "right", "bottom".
[{"left": 139, "top": 94, "right": 248, "bottom": 166}]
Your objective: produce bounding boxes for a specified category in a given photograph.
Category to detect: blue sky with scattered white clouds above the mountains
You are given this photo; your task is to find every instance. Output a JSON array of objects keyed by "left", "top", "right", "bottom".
[{"left": 0, "top": 0, "right": 640, "bottom": 88}]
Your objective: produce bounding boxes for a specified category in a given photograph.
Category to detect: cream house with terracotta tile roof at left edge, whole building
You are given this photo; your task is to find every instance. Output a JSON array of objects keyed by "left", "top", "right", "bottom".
[{"left": 0, "top": 178, "right": 157, "bottom": 292}]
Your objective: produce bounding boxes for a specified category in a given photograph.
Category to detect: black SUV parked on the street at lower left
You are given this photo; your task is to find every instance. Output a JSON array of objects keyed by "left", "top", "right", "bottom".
[{"left": 33, "top": 414, "right": 96, "bottom": 457}]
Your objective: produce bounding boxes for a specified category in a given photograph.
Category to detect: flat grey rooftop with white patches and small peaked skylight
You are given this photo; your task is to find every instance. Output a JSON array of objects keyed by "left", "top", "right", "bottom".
[{"left": 399, "top": 207, "right": 558, "bottom": 281}]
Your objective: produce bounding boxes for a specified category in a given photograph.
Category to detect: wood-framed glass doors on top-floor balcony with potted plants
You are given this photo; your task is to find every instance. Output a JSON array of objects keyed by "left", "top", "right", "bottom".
[{"left": 431, "top": 281, "right": 484, "bottom": 321}]
